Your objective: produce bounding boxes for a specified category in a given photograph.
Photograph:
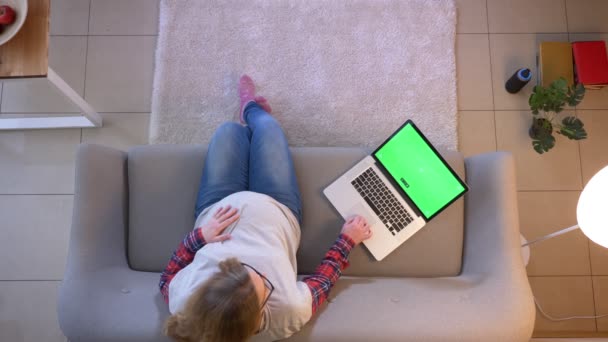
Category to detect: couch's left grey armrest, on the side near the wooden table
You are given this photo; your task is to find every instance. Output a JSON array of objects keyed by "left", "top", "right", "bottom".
[{"left": 64, "top": 144, "right": 128, "bottom": 280}]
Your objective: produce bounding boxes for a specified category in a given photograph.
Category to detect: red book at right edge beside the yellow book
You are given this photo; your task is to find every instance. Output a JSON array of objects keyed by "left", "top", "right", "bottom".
[{"left": 572, "top": 40, "right": 608, "bottom": 85}]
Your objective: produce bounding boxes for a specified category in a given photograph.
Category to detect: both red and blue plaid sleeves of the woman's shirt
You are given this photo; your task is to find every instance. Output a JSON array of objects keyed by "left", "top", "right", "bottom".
[{"left": 158, "top": 228, "right": 355, "bottom": 314}]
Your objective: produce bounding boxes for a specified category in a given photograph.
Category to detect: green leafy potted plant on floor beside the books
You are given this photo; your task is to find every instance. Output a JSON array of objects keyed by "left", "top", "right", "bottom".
[{"left": 528, "top": 78, "right": 587, "bottom": 154}]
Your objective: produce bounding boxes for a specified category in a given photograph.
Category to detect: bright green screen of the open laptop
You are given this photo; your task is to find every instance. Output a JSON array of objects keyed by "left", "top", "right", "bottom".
[{"left": 374, "top": 124, "right": 465, "bottom": 219}]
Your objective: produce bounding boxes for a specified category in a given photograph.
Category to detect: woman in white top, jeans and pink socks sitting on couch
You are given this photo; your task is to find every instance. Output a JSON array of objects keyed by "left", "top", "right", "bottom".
[{"left": 159, "top": 75, "right": 372, "bottom": 342}]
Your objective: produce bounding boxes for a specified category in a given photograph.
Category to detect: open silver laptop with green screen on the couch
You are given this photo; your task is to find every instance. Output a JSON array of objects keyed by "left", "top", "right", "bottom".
[{"left": 323, "top": 120, "right": 468, "bottom": 260}]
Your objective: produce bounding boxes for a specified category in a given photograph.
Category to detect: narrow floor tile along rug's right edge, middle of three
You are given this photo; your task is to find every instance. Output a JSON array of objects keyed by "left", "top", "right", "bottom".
[{"left": 456, "top": 34, "right": 494, "bottom": 110}]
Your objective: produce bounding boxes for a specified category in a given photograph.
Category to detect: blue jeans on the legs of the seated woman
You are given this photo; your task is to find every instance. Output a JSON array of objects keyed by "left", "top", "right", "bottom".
[{"left": 194, "top": 103, "right": 302, "bottom": 223}]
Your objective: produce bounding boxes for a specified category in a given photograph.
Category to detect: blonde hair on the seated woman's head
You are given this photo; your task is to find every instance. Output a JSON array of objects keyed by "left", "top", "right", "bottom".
[{"left": 164, "top": 258, "right": 262, "bottom": 342}]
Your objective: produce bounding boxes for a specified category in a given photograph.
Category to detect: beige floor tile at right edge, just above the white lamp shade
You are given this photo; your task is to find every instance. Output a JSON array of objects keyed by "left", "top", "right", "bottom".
[{"left": 576, "top": 110, "right": 608, "bottom": 184}]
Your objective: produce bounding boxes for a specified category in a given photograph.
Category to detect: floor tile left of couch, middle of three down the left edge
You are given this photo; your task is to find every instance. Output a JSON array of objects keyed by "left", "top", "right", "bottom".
[{"left": 0, "top": 195, "right": 73, "bottom": 280}]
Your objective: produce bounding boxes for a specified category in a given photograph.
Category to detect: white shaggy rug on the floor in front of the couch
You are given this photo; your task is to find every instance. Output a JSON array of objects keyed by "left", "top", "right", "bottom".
[{"left": 150, "top": 0, "right": 457, "bottom": 150}]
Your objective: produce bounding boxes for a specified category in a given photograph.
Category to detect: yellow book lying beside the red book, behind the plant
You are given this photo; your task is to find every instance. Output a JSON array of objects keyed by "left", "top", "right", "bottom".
[{"left": 538, "top": 42, "right": 574, "bottom": 87}]
